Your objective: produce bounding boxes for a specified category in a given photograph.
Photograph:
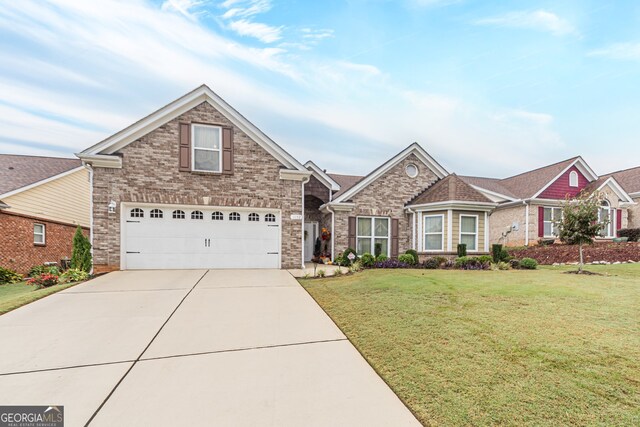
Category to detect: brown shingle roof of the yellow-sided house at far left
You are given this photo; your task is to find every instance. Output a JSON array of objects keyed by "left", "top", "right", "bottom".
[{"left": 0, "top": 154, "right": 82, "bottom": 197}]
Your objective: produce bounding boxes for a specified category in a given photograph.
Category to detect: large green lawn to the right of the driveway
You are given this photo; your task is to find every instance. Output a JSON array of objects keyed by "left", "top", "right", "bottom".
[{"left": 301, "top": 265, "right": 640, "bottom": 426}]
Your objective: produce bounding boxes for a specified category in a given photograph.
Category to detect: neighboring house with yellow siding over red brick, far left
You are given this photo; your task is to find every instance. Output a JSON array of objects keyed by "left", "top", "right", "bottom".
[{"left": 0, "top": 154, "right": 90, "bottom": 273}]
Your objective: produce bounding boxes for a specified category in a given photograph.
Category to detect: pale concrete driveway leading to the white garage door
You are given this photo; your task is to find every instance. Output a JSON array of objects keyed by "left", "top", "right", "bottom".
[{"left": 0, "top": 270, "right": 419, "bottom": 426}]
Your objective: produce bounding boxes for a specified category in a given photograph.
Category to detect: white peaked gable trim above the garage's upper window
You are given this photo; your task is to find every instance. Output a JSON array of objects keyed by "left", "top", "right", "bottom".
[{"left": 76, "top": 84, "right": 307, "bottom": 172}]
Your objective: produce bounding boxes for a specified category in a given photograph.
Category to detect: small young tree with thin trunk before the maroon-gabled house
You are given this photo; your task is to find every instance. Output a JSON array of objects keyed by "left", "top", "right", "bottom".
[{"left": 557, "top": 192, "right": 609, "bottom": 273}]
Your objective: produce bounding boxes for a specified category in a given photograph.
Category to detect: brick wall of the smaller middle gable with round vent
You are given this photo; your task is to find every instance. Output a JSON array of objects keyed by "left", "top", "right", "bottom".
[{"left": 328, "top": 154, "right": 438, "bottom": 255}]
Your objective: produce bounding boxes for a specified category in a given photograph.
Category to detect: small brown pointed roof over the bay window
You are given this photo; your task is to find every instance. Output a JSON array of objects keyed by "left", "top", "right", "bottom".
[{"left": 407, "top": 173, "right": 493, "bottom": 206}]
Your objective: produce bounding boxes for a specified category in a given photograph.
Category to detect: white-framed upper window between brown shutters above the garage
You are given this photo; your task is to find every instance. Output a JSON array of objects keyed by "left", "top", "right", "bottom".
[{"left": 191, "top": 124, "right": 222, "bottom": 172}]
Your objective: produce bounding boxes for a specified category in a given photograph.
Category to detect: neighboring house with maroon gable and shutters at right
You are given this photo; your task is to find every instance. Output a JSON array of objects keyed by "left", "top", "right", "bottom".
[{"left": 461, "top": 156, "right": 636, "bottom": 246}]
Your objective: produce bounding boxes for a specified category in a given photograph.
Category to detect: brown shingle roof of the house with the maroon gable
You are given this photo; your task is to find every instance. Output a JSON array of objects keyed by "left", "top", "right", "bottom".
[{"left": 462, "top": 156, "right": 598, "bottom": 199}]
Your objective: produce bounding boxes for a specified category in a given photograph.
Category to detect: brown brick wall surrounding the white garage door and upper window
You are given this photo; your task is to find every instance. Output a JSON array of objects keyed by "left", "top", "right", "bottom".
[{"left": 93, "top": 102, "right": 303, "bottom": 272}]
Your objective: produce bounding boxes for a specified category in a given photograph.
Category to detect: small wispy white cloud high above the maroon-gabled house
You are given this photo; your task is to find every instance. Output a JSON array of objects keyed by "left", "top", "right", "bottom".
[{"left": 475, "top": 9, "right": 578, "bottom": 36}]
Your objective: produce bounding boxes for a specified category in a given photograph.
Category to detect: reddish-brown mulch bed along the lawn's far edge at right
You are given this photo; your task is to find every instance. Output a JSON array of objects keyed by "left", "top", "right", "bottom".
[{"left": 506, "top": 242, "right": 640, "bottom": 265}]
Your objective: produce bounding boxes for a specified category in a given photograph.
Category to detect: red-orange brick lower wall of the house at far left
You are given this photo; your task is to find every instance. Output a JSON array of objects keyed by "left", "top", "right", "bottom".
[{"left": 0, "top": 211, "right": 89, "bottom": 274}]
